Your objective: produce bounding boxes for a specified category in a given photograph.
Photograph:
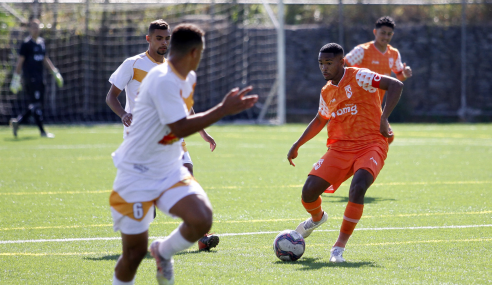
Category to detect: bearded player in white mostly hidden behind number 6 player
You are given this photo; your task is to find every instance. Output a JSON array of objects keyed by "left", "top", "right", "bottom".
[{"left": 106, "top": 19, "right": 219, "bottom": 250}]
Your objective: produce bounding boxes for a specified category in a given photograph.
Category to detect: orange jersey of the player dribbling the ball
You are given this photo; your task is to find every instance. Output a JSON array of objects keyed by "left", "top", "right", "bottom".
[{"left": 318, "top": 67, "right": 388, "bottom": 151}]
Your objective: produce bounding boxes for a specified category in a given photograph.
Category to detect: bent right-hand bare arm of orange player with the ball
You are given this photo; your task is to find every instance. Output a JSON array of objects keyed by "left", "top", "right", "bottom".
[{"left": 379, "top": 76, "right": 403, "bottom": 138}]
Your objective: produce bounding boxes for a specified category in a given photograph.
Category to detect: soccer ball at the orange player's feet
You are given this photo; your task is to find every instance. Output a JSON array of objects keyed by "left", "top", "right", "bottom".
[{"left": 273, "top": 230, "right": 306, "bottom": 261}]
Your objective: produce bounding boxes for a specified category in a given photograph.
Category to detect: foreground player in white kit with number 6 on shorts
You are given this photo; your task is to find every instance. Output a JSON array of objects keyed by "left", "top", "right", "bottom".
[{"left": 110, "top": 24, "right": 258, "bottom": 284}]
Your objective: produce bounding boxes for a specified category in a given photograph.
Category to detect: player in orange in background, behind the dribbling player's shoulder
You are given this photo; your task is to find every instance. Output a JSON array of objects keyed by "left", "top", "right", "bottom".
[{"left": 345, "top": 16, "right": 412, "bottom": 143}]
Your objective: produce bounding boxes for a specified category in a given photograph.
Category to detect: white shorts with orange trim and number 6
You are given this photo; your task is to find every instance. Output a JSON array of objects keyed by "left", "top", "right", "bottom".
[{"left": 109, "top": 167, "right": 208, "bottom": 235}]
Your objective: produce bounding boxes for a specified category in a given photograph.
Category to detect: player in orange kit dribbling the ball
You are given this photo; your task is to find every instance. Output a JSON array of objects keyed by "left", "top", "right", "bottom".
[{"left": 287, "top": 43, "right": 403, "bottom": 262}]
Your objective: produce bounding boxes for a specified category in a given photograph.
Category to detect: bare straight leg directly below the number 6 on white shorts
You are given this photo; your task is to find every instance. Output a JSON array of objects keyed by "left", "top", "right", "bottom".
[{"left": 113, "top": 231, "right": 148, "bottom": 285}]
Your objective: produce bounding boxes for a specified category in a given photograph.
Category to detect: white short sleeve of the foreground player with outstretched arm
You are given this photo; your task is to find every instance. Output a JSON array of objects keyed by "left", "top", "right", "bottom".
[{"left": 152, "top": 77, "right": 188, "bottom": 125}]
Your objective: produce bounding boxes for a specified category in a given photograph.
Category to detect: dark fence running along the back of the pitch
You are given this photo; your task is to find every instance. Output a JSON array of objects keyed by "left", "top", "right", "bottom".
[{"left": 0, "top": 0, "right": 492, "bottom": 124}]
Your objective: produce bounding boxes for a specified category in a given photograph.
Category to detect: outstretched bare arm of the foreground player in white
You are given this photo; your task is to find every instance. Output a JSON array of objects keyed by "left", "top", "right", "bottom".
[{"left": 168, "top": 86, "right": 258, "bottom": 138}]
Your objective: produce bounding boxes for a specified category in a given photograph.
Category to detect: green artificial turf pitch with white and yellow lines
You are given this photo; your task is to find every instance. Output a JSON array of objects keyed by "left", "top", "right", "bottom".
[{"left": 0, "top": 124, "right": 492, "bottom": 284}]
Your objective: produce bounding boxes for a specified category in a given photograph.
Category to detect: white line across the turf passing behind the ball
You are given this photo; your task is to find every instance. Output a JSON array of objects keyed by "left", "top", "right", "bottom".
[{"left": 0, "top": 225, "right": 492, "bottom": 244}]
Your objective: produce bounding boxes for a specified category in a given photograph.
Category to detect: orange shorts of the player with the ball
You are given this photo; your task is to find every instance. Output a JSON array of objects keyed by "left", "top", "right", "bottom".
[{"left": 309, "top": 146, "right": 386, "bottom": 193}]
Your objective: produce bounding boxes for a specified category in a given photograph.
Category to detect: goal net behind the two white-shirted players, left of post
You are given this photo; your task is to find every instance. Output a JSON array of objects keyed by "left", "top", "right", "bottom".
[{"left": 0, "top": 0, "right": 277, "bottom": 124}]
